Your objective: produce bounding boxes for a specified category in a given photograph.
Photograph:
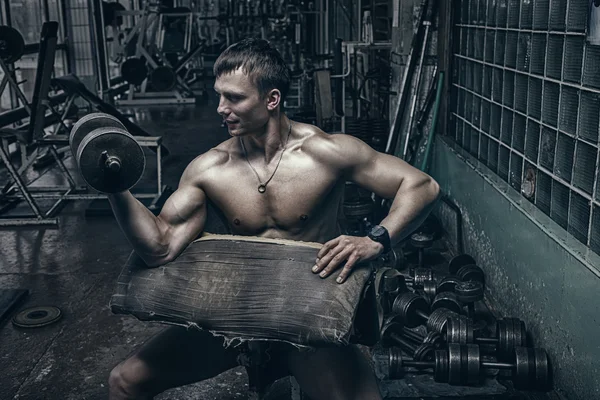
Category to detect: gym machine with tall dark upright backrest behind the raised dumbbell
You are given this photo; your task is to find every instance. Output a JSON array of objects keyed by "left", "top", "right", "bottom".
[{"left": 0, "top": 21, "right": 168, "bottom": 228}]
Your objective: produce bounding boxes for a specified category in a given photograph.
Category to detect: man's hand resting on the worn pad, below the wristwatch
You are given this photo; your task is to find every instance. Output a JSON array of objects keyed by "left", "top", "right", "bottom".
[{"left": 312, "top": 235, "right": 383, "bottom": 283}]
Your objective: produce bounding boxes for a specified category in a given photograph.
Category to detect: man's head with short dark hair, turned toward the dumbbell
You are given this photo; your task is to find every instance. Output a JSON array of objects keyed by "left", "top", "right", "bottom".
[{"left": 213, "top": 39, "right": 290, "bottom": 136}]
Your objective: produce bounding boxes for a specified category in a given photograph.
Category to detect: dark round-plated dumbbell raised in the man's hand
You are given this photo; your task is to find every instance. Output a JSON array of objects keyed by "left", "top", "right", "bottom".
[{"left": 69, "top": 113, "right": 146, "bottom": 193}]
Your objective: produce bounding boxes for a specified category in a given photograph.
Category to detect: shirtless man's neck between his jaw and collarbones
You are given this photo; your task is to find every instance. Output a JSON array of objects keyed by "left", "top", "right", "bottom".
[{"left": 240, "top": 114, "right": 291, "bottom": 164}]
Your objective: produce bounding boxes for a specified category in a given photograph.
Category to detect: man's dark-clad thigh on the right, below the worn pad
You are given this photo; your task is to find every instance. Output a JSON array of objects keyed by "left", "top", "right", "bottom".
[{"left": 288, "top": 346, "right": 381, "bottom": 400}]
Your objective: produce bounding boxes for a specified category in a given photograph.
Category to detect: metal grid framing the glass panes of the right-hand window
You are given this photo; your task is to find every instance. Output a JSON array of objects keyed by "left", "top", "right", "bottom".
[{"left": 451, "top": 0, "right": 600, "bottom": 251}]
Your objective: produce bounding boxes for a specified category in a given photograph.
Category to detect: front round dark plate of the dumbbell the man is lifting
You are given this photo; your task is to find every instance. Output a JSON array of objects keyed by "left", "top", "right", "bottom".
[{"left": 76, "top": 128, "right": 146, "bottom": 193}]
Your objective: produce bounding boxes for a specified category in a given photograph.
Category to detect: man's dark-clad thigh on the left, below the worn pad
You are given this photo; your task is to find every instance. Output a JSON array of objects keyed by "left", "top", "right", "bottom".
[{"left": 133, "top": 326, "right": 238, "bottom": 393}]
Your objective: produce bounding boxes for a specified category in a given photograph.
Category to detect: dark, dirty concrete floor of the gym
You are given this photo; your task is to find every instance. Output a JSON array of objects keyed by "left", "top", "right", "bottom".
[{"left": 0, "top": 101, "right": 556, "bottom": 400}]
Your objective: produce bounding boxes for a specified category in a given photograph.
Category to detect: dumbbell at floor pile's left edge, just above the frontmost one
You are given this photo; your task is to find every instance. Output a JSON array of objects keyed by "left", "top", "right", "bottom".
[{"left": 381, "top": 316, "right": 441, "bottom": 361}]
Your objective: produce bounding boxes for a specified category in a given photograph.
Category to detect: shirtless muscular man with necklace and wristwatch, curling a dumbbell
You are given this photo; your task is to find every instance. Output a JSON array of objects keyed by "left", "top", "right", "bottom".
[{"left": 109, "top": 39, "right": 439, "bottom": 400}]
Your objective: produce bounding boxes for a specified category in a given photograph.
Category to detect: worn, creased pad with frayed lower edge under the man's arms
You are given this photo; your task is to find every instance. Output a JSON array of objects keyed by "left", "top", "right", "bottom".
[{"left": 110, "top": 235, "right": 372, "bottom": 346}]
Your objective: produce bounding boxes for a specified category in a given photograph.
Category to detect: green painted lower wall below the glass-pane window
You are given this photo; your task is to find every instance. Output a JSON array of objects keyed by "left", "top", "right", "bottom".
[{"left": 429, "top": 138, "right": 600, "bottom": 400}]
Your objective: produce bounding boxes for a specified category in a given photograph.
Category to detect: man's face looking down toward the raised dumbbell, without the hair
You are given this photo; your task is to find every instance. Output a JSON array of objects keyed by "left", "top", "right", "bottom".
[{"left": 215, "top": 69, "right": 269, "bottom": 136}]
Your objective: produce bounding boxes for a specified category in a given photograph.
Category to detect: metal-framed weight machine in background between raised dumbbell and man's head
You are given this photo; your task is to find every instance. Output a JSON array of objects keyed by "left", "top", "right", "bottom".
[{"left": 95, "top": 0, "right": 216, "bottom": 105}]
